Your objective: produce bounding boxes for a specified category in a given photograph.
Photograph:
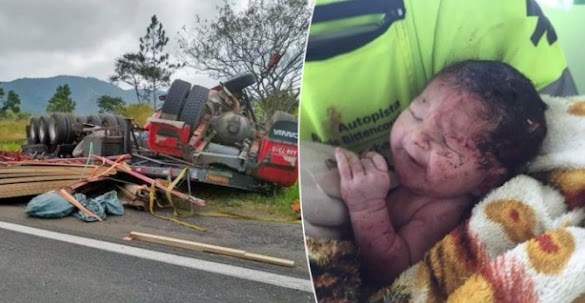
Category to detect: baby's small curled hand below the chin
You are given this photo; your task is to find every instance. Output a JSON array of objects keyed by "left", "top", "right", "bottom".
[{"left": 335, "top": 148, "right": 391, "bottom": 211}]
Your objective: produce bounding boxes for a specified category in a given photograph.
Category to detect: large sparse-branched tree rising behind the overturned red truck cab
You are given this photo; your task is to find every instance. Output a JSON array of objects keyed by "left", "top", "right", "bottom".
[{"left": 179, "top": 0, "right": 311, "bottom": 123}]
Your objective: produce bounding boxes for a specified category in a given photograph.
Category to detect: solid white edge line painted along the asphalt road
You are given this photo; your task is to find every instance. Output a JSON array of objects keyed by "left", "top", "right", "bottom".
[{"left": 0, "top": 221, "right": 313, "bottom": 293}]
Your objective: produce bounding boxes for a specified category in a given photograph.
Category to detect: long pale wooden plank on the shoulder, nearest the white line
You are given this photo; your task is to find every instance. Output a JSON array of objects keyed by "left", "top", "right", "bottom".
[{"left": 129, "top": 231, "right": 295, "bottom": 267}]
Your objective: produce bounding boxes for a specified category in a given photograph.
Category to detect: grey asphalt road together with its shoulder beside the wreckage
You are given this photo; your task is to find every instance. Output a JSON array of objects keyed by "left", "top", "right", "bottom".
[{"left": 0, "top": 204, "right": 314, "bottom": 303}]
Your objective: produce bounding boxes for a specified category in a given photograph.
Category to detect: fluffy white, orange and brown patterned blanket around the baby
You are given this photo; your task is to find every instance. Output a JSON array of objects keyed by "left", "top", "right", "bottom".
[{"left": 307, "top": 96, "right": 585, "bottom": 303}]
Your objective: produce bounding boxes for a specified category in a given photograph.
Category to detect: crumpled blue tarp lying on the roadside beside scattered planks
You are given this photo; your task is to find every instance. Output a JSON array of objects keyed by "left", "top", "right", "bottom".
[{"left": 25, "top": 190, "right": 124, "bottom": 222}]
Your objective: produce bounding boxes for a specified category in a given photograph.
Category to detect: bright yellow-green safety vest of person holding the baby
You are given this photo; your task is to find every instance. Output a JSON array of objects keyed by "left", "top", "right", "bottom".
[{"left": 299, "top": 0, "right": 567, "bottom": 162}]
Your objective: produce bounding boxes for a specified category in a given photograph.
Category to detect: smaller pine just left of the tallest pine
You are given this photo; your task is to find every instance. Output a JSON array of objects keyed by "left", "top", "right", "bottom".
[{"left": 109, "top": 53, "right": 148, "bottom": 103}]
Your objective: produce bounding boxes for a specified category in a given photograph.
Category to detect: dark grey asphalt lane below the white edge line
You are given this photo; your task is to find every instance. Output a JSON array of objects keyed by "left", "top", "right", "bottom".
[{"left": 0, "top": 224, "right": 313, "bottom": 302}]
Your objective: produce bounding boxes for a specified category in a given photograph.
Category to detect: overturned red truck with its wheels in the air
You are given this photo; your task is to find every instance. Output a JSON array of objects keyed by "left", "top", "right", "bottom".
[{"left": 22, "top": 74, "right": 298, "bottom": 191}]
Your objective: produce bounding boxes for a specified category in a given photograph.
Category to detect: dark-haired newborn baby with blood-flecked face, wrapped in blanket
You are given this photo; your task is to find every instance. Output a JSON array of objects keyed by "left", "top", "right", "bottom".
[{"left": 335, "top": 61, "right": 546, "bottom": 284}]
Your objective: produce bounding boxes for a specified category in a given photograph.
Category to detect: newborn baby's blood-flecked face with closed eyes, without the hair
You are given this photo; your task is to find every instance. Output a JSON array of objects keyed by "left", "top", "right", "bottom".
[{"left": 390, "top": 80, "right": 501, "bottom": 198}]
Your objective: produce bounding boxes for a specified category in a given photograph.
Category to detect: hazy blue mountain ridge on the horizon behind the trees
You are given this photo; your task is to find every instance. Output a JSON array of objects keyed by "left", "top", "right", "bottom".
[{"left": 0, "top": 76, "right": 162, "bottom": 115}]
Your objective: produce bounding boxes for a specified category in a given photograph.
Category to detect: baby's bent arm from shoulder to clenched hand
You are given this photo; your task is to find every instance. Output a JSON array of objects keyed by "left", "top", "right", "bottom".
[{"left": 336, "top": 150, "right": 461, "bottom": 285}]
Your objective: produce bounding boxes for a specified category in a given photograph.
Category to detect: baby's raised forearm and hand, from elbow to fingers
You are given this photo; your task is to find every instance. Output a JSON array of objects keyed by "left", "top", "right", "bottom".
[{"left": 335, "top": 149, "right": 400, "bottom": 284}]
